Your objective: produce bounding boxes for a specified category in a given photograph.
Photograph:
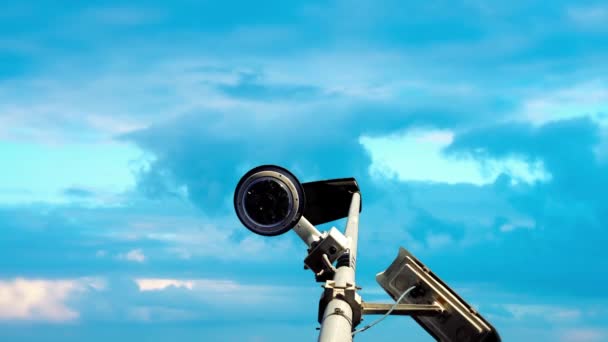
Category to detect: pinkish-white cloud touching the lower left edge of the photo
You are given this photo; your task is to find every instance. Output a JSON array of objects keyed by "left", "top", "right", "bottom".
[{"left": 0, "top": 278, "right": 105, "bottom": 322}]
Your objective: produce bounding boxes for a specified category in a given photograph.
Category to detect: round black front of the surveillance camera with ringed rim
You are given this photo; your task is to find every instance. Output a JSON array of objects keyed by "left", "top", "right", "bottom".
[{"left": 234, "top": 165, "right": 306, "bottom": 236}]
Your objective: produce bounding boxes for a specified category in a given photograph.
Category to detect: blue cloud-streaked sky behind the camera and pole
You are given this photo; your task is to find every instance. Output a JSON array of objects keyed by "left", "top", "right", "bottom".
[{"left": 0, "top": 0, "right": 608, "bottom": 341}]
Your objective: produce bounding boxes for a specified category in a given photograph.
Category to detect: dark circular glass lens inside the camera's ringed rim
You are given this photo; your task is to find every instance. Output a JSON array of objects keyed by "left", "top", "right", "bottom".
[{"left": 244, "top": 178, "right": 291, "bottom": 226}]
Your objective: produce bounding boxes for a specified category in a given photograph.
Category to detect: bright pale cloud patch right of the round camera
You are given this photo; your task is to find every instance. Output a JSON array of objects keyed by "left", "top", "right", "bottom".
[{"left": 359, "top": 130, "right": 550, "bottom": 185}]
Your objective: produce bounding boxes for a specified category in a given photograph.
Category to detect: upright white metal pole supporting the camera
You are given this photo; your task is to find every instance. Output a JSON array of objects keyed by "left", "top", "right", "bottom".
[{"left": 319, "top": 192, "right": 361, "bottom": 342}]
